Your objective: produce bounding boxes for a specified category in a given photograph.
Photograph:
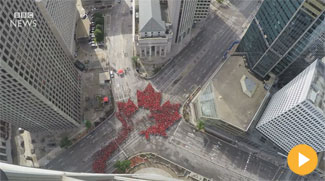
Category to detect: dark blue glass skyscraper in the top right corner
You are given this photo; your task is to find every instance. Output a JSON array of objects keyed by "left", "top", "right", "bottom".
[{"left": 237, "top": 0, "right": 325, "bottom": 78}]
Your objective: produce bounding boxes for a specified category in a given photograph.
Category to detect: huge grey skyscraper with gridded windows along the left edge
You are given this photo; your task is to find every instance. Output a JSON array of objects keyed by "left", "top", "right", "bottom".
[{"left": 0, "top": 0, "right": 81, "bottom": 131}]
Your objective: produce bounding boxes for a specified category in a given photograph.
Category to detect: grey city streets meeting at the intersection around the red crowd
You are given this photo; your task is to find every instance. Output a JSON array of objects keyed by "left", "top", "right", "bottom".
[{"left": 46, "top": 0, "right": 320, "bottom": 180}]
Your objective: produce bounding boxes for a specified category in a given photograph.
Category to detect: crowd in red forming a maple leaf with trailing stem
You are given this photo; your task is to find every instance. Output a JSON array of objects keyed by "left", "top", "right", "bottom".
[{"left": 93, "top": 84, "right": 181, "bottom": 173}]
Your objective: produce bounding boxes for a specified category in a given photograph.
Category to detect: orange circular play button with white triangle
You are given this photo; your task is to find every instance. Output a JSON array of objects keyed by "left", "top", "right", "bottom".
[{"left": 287, "top": 144, "right": 318, "bottom": 175}]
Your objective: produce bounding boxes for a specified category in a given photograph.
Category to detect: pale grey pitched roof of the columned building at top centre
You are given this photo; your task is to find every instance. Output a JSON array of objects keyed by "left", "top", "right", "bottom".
[{"left": 139, "top": 0, "right": 166, "bottom": 32}]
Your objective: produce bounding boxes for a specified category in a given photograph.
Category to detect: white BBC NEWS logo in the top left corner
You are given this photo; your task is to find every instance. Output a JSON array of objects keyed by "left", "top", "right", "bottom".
[{"left": 10, "top": 12, "right": 37, "bottom": 28}]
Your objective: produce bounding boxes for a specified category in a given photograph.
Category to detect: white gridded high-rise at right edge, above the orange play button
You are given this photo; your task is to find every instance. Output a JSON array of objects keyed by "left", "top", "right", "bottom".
[{"left": 256, "top": 59, "right": 325, "bottom": 152}]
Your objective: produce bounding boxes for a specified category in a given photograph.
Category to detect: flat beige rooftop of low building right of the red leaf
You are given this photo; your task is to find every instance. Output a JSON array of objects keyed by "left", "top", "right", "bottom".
[{"left": 198, "top": 56, "right": 267, "bottom": 131}]
